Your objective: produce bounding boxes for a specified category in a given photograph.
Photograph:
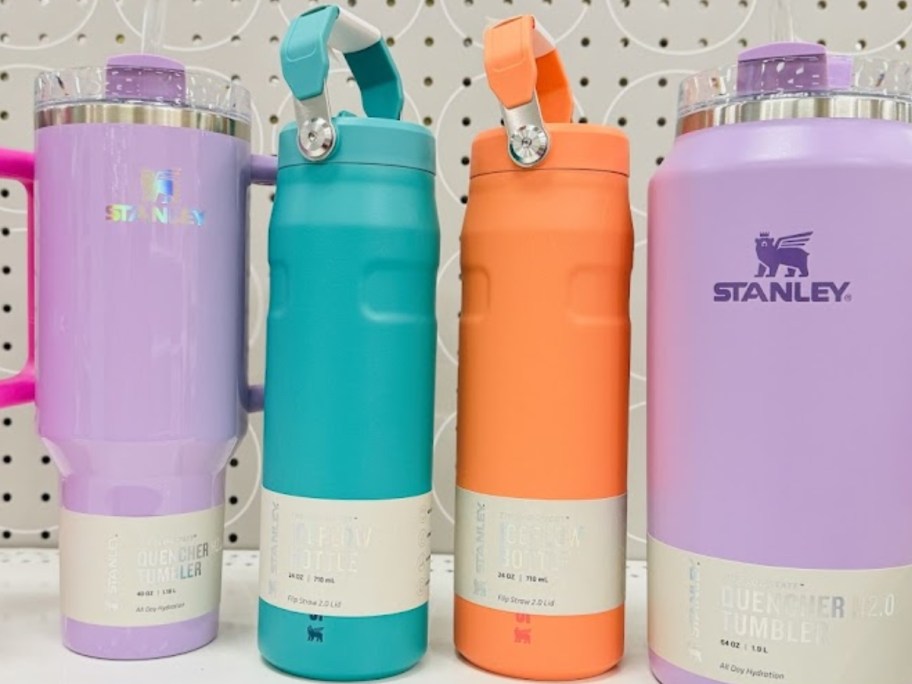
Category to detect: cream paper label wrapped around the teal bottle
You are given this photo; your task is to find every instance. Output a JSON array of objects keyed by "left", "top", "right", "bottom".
[{"left": 260, "top": 488, "right": 431, "bottom": 617}]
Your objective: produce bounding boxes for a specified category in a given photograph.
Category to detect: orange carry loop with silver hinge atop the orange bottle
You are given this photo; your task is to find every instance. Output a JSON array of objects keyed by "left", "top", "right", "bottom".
[{"left": 485, "top": 15, "right": 573, "bottom": 167}]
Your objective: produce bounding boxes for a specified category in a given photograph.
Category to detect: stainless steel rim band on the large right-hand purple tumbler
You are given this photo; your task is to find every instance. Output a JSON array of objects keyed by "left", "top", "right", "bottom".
[{"left": 677, "top": 95, "right": 912, "bottom": 135}]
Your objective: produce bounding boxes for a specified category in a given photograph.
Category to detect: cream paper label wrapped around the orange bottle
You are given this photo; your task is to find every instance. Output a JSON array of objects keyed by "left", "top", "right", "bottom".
[{"left": 456, "top": 487, "right": 627, "bottom": 615}]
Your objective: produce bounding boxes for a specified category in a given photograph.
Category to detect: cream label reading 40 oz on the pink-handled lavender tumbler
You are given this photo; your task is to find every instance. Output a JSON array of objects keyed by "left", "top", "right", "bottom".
[{"left": 60, "top": 506, "right": 225, "bottom": 627}]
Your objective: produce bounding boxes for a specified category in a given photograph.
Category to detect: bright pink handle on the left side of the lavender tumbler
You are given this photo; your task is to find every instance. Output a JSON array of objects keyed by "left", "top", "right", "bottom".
[{"left": 0, "top": 149, "right": 35, "bottom": 408}]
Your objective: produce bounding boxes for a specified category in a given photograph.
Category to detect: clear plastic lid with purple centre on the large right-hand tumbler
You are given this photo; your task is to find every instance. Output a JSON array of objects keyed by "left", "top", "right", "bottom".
[{"left": 678, "top": 43, "right": 912, "bottom": 117}]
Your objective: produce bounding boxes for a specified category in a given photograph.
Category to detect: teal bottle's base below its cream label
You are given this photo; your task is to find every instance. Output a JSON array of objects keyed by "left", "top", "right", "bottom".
[{"left": 257, "top": 599, "right": 428, "bottom": 682}]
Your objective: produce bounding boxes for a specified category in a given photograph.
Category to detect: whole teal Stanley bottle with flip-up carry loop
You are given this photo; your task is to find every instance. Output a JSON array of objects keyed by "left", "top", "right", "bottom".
[{"left": 259, "top": 6, "right": 440, "bottom": 680}]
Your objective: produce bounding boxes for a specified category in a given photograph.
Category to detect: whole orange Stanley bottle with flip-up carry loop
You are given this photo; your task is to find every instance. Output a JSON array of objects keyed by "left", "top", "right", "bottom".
[{"left": 455, "top": 16, "right": 633, "bottom": 680}]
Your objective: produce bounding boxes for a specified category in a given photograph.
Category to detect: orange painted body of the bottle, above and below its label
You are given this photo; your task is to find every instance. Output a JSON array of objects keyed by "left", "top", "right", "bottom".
[{"left": 455, "top": 162, "right": 633, "bottom": 679}]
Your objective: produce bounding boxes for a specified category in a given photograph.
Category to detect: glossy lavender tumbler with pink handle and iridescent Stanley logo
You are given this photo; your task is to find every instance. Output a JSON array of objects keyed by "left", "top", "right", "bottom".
[{"left": 0, "top": 56, "right": 275, "bottom": 659}]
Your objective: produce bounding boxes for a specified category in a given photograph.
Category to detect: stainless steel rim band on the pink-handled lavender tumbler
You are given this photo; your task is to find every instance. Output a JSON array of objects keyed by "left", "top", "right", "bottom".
[{"left": 35, "top": 102, "right": 250, "bottom": 141}]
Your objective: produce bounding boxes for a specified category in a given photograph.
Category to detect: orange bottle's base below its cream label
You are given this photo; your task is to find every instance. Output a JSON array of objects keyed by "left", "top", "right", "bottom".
[{"left": 455, "top": 597, "right": 624, "bottom": 681}]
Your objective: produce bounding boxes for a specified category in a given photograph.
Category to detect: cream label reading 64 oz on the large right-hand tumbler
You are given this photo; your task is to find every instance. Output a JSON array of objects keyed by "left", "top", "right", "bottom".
[{"left": 649, "top": 538, "right": 912, "bottom": 684}]
